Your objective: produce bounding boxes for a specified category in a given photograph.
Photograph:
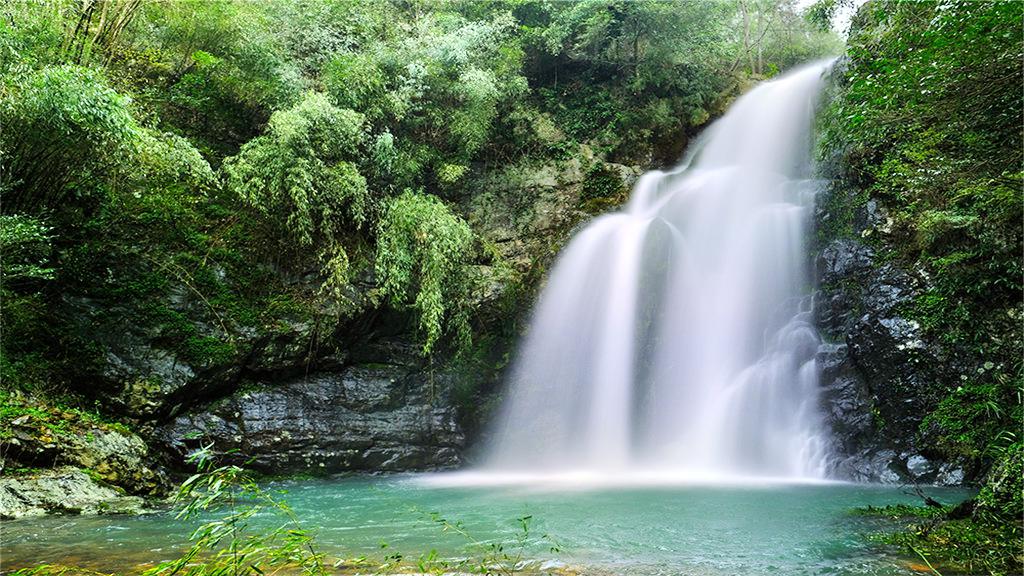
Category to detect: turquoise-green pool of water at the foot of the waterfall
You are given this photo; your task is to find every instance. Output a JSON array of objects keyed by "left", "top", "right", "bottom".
[{"left": 2, "top": 477, "right": 970, "bottom": 576}]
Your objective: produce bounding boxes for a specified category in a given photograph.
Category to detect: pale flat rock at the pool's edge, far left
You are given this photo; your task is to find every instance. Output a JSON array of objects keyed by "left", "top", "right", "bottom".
[{"left": 0, "top": 466, "right": 143, "bottom": 519}]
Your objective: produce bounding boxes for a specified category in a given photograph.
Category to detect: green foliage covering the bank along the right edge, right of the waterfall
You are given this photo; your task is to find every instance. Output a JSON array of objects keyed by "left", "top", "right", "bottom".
[{"left": 823, "top": 0, "right": 1024, "bottom": 574}]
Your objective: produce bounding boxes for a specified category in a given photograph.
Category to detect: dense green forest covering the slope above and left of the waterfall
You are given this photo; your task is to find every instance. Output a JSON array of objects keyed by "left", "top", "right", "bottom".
[{"left": 0, "top": 0, "right": 838, "bottom": 373}]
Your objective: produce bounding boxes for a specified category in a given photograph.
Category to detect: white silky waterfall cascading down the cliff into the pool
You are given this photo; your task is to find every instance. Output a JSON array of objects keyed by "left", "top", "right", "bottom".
[{"left": 483, "top": 63, "right": 830, "bottom": 479}]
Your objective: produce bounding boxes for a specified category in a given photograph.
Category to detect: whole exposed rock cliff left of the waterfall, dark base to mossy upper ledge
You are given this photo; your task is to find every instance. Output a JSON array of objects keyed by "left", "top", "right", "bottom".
[{"left": 130, "top": 155, "right": 641, "bottom": 474}]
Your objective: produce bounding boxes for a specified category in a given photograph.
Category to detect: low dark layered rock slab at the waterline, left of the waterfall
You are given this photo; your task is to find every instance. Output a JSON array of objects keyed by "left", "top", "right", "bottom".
[{"left": 161, "top": 365, "right": 465, "bottom": 474}]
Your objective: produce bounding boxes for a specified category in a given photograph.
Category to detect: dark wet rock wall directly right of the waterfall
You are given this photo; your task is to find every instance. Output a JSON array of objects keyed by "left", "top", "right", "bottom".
[{"left": 815, "top": 182, "right": 971, "bottom": 485}]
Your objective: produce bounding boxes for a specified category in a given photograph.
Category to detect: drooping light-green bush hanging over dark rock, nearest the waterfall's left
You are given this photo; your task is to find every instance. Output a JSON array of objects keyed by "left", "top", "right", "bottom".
[{"left": 376, "top": 191, "right": 473, "bottom": 354}]
